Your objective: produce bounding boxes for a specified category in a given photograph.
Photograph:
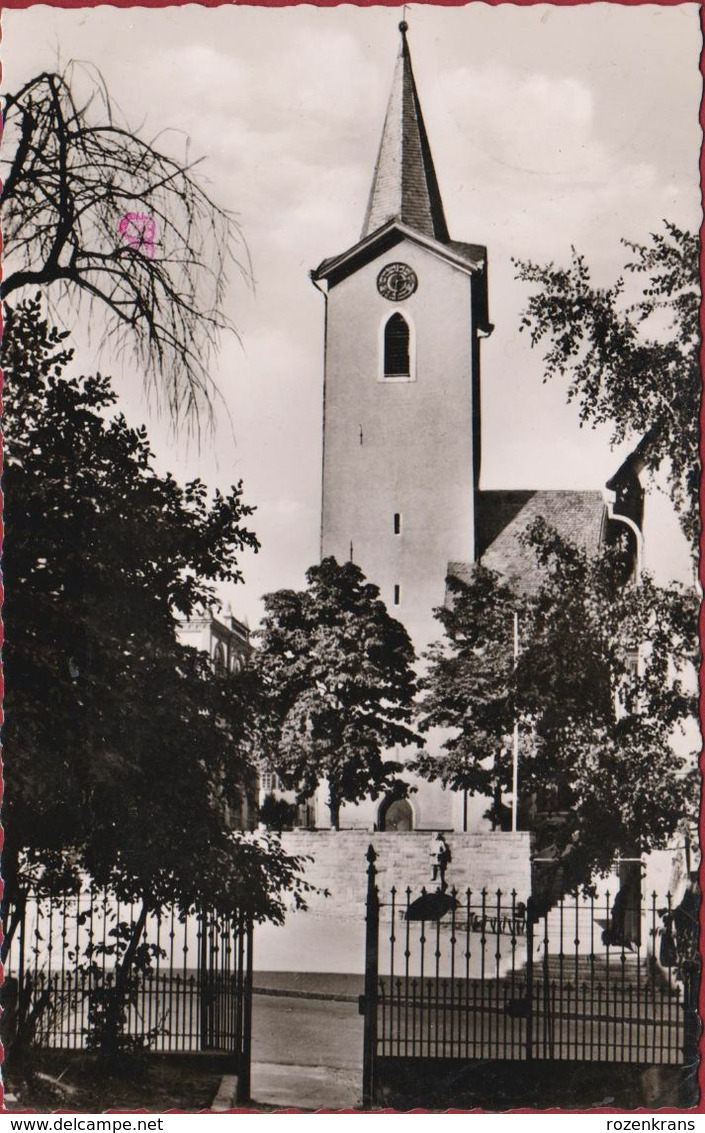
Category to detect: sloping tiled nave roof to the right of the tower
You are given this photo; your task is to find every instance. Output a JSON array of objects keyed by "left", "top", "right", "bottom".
[{"left": 448, "top": 491, "right": 608, "bottom": 594}]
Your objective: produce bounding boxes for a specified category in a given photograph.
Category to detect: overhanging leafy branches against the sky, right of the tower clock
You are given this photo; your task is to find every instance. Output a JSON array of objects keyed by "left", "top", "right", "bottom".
[{"left": 517, "top": 221, "right": 700, "bottom": 546}]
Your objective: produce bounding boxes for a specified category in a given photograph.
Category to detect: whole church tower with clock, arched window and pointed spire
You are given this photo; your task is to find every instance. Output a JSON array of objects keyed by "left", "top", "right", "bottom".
[{"left": 312, "top": 23, "right": 491, "bottom": 651}]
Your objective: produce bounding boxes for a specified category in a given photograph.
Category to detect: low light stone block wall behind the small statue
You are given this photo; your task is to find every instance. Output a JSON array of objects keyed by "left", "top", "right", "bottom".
[{"left": 282, "top": 830, "right": 530, "bottom": 919}]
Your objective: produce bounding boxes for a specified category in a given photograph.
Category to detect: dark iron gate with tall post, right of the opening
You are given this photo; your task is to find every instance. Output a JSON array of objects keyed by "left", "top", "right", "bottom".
[{"left": 360, "top": 846, "right": 698, "bottom": 1106}]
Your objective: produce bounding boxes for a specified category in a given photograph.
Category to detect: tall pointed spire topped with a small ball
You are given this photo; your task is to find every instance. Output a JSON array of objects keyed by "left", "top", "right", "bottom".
[{"left": 363, "top": 22, "right": 449, "bottom": 244}]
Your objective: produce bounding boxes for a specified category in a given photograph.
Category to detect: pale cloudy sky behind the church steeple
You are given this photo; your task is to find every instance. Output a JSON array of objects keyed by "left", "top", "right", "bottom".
[{"left": 2, "top": 3, "right": 700, "bottom": 625}]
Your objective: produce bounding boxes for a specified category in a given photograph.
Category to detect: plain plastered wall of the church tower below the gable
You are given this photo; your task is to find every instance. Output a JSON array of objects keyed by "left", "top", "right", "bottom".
[{"left": 321, "top": 240, "right": 476, "bottom": 651}]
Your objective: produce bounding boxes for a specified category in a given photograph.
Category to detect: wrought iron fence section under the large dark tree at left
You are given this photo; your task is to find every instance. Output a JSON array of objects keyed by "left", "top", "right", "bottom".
[{"left": 3, "top": 888, "right": 252, "bottom": 1076}]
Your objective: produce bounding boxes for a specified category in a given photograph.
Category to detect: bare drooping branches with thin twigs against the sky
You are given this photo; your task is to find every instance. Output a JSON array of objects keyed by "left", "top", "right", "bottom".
[{"left": 0, "top": 63, "right": 249, "bottom": 420}]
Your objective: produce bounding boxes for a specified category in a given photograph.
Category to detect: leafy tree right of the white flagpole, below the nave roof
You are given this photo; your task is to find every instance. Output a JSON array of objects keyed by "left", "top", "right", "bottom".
[{"left": 518, "top": 525, "right": 698, "bottom": 879}]
